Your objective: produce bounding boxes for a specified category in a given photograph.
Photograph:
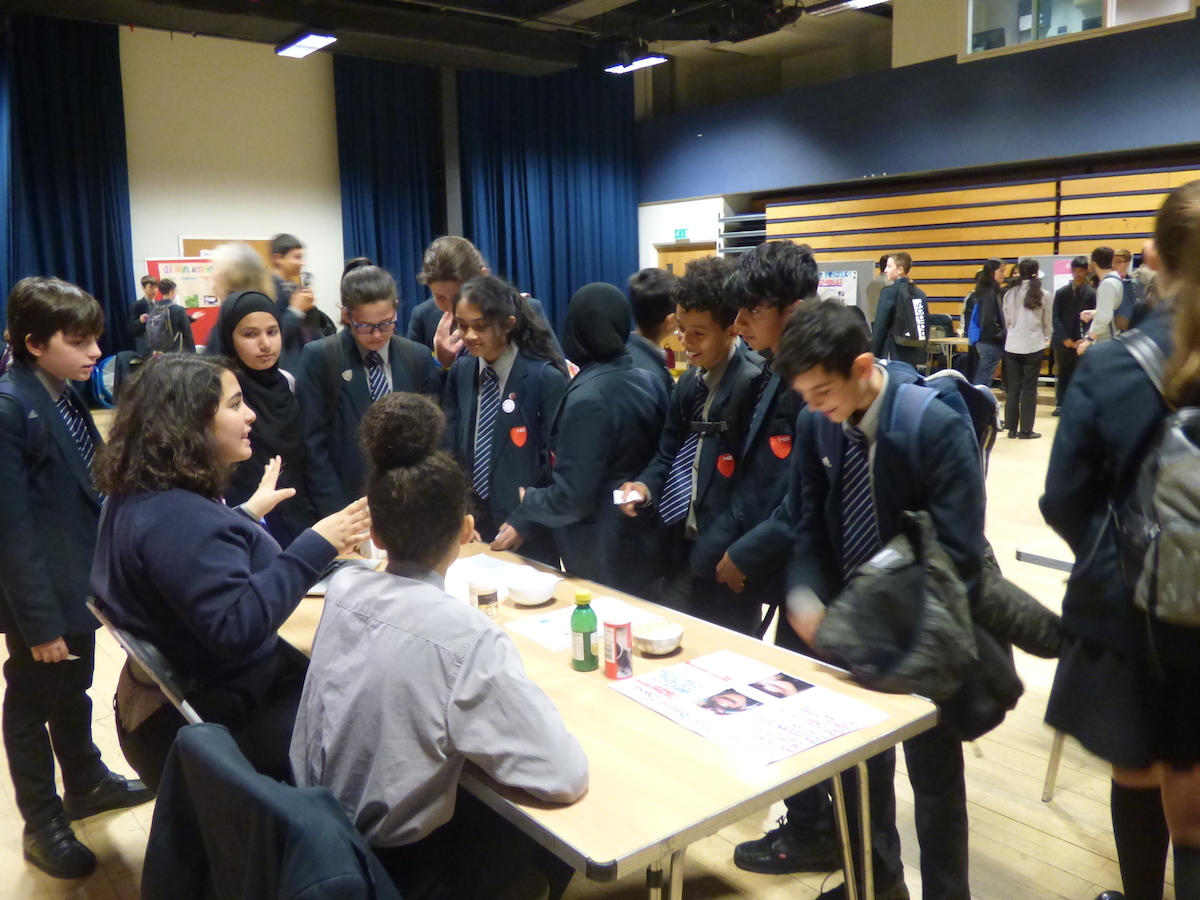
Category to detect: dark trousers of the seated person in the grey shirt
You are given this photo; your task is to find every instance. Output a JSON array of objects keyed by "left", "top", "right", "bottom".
[{"left": 372, "top": 788, "right": 575, "bottom": 900}]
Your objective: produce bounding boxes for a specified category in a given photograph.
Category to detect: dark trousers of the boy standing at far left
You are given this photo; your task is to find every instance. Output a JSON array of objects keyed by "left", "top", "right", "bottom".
[{"left": 2, "top": 632, "right": 108, "bottom": 830}]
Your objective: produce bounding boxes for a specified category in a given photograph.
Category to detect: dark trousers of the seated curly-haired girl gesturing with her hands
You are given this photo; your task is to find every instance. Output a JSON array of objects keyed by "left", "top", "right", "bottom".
[{"left": 116, "top": 642, "right": 307, "bottom": 791}]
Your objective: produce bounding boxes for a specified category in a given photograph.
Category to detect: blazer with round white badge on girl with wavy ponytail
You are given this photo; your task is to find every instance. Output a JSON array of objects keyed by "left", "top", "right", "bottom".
[{"left": 442, "top": 353, "right": 568, "bottom": 538}]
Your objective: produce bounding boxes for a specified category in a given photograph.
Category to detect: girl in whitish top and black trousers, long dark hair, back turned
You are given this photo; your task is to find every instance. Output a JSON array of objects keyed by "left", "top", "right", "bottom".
[{"left": 1004, "top": 257, "right": 1054, "bottom": 440}]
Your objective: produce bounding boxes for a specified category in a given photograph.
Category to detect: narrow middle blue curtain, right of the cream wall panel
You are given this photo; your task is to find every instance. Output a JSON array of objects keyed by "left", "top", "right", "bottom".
[{"left": 334, "top": 55, "right": 442, "bottom": 322}]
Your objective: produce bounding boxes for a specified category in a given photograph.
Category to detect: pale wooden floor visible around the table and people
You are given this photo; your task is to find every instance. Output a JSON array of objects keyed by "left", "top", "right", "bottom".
[{"left": 0, "top": 406, "right": 1152, "bottom": 900}]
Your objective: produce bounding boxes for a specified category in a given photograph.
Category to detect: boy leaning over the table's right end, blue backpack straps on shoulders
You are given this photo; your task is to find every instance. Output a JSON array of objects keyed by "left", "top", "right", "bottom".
[{"left": 734, "top": 301, "right": 986, "bottom": 900}]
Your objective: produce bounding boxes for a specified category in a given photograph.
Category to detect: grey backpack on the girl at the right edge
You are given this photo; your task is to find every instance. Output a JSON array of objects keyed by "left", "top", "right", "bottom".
[{"left": 1112, "top": 329, "right": 1200, "bottom": 628}]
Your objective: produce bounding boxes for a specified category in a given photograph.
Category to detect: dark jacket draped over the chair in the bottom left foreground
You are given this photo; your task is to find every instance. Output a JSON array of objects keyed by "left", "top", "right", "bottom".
[{"left": 142, "top": 724, "right": 400, "bottom": 900}]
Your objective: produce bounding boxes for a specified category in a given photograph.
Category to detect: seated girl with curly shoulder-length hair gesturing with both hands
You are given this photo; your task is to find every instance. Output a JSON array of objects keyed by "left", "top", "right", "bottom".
[{"left": 91, "top": 354, "right": 370, "bottom": 787}]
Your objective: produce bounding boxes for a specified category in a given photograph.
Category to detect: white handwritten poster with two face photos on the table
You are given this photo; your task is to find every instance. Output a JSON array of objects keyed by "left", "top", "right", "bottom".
[{"left": 611, "top": 650, "right": 887, "bottom": 764}]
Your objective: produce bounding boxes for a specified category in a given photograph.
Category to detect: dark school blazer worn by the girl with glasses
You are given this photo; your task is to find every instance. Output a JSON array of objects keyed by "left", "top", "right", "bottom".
[{"left": 296, "top": 329, "right": 442, "bottom": 517}]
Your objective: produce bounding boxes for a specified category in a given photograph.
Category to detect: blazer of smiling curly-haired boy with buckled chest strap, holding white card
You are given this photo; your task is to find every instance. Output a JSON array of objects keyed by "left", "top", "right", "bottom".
[{"left": 634, "top": 344, "right": 763, "bottom": 566}]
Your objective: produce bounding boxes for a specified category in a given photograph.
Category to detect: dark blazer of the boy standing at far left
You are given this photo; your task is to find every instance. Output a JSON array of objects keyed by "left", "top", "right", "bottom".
[{"left": 0, "top": 362, "right": 101, "bottom": 647}]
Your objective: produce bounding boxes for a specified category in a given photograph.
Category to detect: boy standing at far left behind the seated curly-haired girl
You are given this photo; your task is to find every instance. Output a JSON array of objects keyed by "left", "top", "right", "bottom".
[{"left": 0, "top": 277, "right": 154, "bottom": 878}]
